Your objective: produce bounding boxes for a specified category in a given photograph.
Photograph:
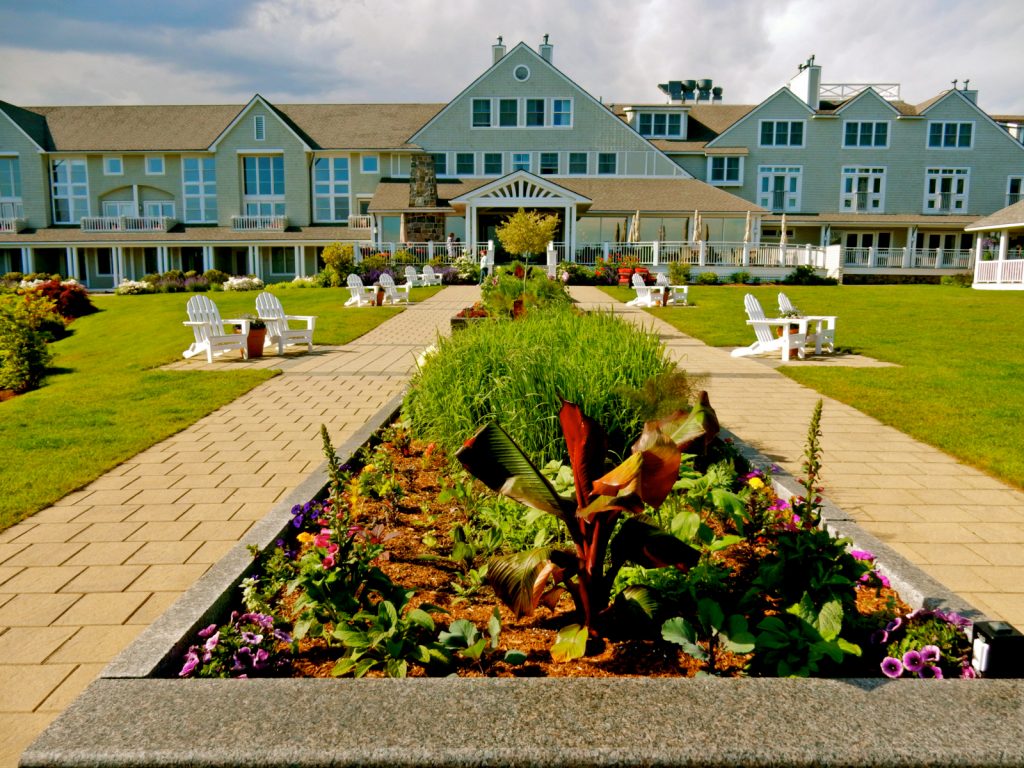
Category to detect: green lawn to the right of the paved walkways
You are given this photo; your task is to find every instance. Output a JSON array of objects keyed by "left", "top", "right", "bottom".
[{"left": 609, "top": 286, "right": 1024, "bottom": 487}]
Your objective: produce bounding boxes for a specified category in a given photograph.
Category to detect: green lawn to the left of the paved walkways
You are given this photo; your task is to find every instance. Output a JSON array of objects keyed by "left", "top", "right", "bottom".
[{"left": 0, "top": 288, "right": 440, "bottom": 530}]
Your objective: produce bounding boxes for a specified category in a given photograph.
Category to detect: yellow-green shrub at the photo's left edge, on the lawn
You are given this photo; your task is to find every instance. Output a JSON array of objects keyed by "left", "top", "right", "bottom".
[{"left": 0, "top": 295, "right": 53, "bottom": 392}]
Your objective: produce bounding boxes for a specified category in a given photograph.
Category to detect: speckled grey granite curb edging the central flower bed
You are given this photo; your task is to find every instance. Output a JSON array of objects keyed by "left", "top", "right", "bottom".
[{"left": 22, "top": 396, "right": 1024, "bottom": 767}]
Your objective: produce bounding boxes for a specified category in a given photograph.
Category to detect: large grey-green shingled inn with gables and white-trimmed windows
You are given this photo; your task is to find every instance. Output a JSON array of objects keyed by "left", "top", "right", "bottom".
[{"left": 0, "top": 38, "right": 1024, "bottom": 290}]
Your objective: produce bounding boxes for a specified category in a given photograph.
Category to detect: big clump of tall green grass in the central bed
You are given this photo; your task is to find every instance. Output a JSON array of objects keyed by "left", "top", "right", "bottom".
[{"left": 404, "top": 306, "right": 674, "bottom": 466}]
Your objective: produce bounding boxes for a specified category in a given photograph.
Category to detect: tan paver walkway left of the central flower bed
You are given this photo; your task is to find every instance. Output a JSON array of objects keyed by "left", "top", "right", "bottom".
[{"left": 0, "top": 287, "right": 478, "bottom": 768}]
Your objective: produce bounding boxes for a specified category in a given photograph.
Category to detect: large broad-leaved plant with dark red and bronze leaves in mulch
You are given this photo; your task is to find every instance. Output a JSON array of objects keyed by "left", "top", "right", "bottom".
[{"left": 456, "top": 393, "right": 718, "bottom": 633}]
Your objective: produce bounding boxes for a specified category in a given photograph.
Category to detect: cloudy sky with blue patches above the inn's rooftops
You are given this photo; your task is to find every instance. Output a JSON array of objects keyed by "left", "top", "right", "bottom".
[{"left": 6, "top": 0, "right": 1024, "bottom": 115}]
